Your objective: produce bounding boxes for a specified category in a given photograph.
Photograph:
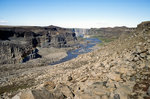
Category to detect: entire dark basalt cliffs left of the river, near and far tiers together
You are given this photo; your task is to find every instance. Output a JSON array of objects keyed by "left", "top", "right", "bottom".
[{"left": 0, "top": 26, "right": 76, "bottom": 64}]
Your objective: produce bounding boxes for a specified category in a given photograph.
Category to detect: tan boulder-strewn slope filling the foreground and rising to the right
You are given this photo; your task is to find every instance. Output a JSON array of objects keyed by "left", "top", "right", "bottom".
[{"left": 0, "top": 22, "right": 150, "bottom": 99}]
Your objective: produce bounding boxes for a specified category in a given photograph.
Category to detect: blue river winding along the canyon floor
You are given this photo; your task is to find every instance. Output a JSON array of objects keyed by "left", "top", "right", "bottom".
[{"left": 50, "top": 38, "right": 101, "bottom": 65}]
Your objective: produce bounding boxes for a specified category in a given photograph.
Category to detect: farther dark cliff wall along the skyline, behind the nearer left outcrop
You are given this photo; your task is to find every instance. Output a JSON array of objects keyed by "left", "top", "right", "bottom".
[{"left": 0, "top": 26, "right": 76, "bottom": 47}]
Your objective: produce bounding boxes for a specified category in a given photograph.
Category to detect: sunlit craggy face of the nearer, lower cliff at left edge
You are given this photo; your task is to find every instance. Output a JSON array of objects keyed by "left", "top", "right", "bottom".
[{"left": 0, "top": 41, "right": 32, "bottom": 64}]
